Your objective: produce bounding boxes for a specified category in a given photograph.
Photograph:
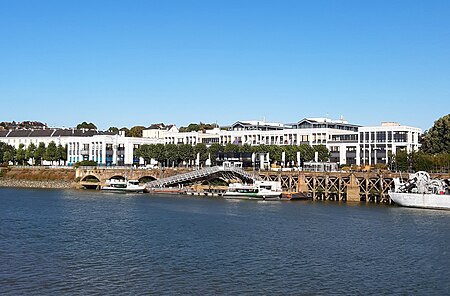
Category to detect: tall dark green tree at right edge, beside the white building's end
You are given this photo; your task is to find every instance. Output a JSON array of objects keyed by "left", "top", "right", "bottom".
[{"left": 421, "top": 114, "right": 450, "bottom": 154}]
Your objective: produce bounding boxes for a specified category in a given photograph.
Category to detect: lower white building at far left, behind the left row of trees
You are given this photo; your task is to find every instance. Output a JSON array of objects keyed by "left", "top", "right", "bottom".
[{"left": 0, "top": 129, "right": 164, "bottom": 165}]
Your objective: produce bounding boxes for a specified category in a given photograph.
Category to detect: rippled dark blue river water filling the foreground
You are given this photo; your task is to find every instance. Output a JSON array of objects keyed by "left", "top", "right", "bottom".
[{"left": 0, "top": 189, "right": 450, "bottom": 295}]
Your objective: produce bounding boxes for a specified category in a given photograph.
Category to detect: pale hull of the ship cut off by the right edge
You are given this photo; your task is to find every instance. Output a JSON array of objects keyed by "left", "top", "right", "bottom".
[{"left": 389, "top": 192, "right": 450, "bottom": 210}]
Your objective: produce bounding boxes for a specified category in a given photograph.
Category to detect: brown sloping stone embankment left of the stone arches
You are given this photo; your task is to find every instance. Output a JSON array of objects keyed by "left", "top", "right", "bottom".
[{"left": 0, "top": 167, "right": 77, "bottom": 189}]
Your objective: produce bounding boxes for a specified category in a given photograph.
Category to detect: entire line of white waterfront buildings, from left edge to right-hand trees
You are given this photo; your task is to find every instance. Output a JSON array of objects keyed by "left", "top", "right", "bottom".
[{"left": 0, "top": 118, "right": 422, "bottom": 165}]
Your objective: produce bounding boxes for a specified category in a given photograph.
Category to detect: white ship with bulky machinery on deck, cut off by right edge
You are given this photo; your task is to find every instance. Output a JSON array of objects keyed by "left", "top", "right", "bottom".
[{"left": 389, "top": 172, "right": 450, "bottom": 209}]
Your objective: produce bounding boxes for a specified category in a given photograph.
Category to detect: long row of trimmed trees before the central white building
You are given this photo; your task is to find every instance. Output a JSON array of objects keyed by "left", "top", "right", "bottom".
[{"left": 135, "top": 143, "right": 330, "bottom": 166}]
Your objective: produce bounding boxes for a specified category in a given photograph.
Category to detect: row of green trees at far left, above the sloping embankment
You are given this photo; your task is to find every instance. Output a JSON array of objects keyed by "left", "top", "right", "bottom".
[{"left": 0, "top": 141, "right": 67, "bottom": 165}]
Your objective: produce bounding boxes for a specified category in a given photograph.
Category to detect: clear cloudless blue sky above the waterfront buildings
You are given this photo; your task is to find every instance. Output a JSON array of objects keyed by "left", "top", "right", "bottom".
[{"left": 0, "top": 0, "right": 450, "bottom": 129}]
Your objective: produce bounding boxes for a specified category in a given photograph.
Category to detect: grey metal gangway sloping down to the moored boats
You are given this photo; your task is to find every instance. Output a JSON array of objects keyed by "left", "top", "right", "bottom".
[{"left": 145, "top": 166, "right": 262, "bottom": 188}]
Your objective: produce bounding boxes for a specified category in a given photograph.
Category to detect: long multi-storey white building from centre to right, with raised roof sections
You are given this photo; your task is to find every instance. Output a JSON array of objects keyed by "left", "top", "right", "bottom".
[{"left": 144, "top": 118, "right": 422, "bottom": 165}]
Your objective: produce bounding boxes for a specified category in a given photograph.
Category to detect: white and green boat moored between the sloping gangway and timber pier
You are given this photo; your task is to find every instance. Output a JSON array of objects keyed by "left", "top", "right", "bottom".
[{"left": 223, "top": 181, "right": 281, "bottom": 200}]
